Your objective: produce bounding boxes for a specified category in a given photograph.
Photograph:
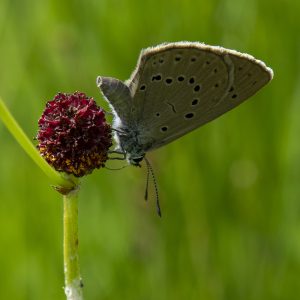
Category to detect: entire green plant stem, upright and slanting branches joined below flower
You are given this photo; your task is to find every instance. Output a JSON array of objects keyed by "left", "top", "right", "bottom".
[{"left": 0, "top": 98, "right": 82, "bottom": 300}]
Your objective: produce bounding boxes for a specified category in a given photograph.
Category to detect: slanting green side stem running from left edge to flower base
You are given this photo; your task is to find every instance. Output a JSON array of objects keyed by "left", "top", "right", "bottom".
[{"left": 0, "top": 97, "right": 76, "bottom": 189}]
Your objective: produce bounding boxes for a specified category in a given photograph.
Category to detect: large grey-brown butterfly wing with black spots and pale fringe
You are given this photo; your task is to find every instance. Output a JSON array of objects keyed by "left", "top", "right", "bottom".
[{"left": 125, "top": 42, "right": 273, "bottom": 151}]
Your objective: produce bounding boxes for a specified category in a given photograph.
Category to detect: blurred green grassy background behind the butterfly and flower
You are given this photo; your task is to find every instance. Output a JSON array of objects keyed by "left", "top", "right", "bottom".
[{"left": 0, "top": 0, "right": 300, "bottom": 300}]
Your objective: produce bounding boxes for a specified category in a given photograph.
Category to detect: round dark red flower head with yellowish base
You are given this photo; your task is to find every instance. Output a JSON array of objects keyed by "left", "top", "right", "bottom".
[{"left": 37, "top": 92, "right": 112, "bottom": 177}]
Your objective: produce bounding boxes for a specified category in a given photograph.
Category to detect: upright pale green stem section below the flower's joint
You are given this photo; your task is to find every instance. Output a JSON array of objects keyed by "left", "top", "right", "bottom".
[{"left": 63, "top": 190, "right": 83, "bottom": 300}]
